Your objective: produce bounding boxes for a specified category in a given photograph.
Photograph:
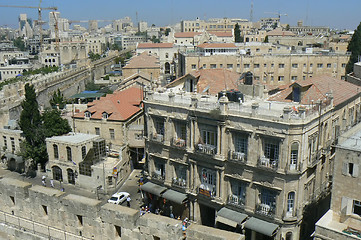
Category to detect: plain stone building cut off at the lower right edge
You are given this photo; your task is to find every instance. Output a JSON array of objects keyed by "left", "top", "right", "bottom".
[{"left": 314, "top": 124, "right": 361, "bottom": 240}]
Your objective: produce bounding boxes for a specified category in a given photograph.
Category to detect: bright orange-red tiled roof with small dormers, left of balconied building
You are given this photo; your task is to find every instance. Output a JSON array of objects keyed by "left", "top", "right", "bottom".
[{"left": 74, "top": 87, "right": 143, "bottom": 121}]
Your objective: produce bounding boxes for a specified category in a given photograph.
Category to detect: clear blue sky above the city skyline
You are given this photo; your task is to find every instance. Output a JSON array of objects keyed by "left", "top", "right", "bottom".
[{"left": 0, "top": 0, "right": 361, "bottom": 30}]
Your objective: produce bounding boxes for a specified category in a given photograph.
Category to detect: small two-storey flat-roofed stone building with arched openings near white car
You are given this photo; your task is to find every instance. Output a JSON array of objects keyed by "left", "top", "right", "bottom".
[{"left": 46, "top": 133, "right": 130, "bottom": 193}]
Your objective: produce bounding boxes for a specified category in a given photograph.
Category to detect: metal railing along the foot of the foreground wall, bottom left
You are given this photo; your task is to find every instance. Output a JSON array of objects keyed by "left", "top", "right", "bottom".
[{"left": 0, "top": 211, "right": 91, "bottom": 240}]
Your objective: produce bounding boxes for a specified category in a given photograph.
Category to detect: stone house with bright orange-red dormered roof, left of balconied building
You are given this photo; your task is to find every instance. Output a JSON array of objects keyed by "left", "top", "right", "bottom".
[{"left": 73, "top": 86, "right": 144, "bottom": 169}]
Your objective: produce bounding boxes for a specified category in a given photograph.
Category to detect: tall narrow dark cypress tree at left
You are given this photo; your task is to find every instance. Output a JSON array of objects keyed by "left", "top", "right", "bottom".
[{"left": 19, "top": 83, "right": 48, "bottom": 169}]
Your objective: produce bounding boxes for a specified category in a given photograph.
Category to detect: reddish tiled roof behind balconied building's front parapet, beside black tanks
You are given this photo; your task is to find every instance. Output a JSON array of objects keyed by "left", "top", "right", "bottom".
[{"left": 166, "top": 69, "right": 240, "bottom": 95}]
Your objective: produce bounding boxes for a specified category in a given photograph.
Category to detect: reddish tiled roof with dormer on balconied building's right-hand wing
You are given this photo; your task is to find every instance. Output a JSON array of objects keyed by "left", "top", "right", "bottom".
[{"left": 269, "top": 75, "right": 361, "bottom": 106}]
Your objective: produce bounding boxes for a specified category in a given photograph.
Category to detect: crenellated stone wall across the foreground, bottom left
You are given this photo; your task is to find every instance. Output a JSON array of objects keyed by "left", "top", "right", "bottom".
[{"left": 0, "top": 178, "right": 244, "bottom": 240}]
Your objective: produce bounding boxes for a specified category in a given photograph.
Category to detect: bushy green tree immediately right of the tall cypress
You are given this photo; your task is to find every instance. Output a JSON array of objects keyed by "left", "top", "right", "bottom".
[{"left": 42, "top": 109, "right": 71, "bottom": 137}]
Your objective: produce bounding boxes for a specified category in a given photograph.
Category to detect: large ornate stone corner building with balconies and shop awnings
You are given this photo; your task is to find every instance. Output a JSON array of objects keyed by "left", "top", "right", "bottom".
[{"left": 143, "top": 69, "right": 361, "bottom": 240}]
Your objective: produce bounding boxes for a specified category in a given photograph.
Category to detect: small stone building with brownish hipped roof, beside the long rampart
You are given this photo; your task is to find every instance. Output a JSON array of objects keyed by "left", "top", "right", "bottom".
[{"left": 123, "top": 52, "right": 161, "bottom": 79}]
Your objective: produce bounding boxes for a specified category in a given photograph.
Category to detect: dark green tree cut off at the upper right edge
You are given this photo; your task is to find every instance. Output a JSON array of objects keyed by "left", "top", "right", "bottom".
[{"left": 345, "top": 23, "right": 361, "bottom": 74}]
